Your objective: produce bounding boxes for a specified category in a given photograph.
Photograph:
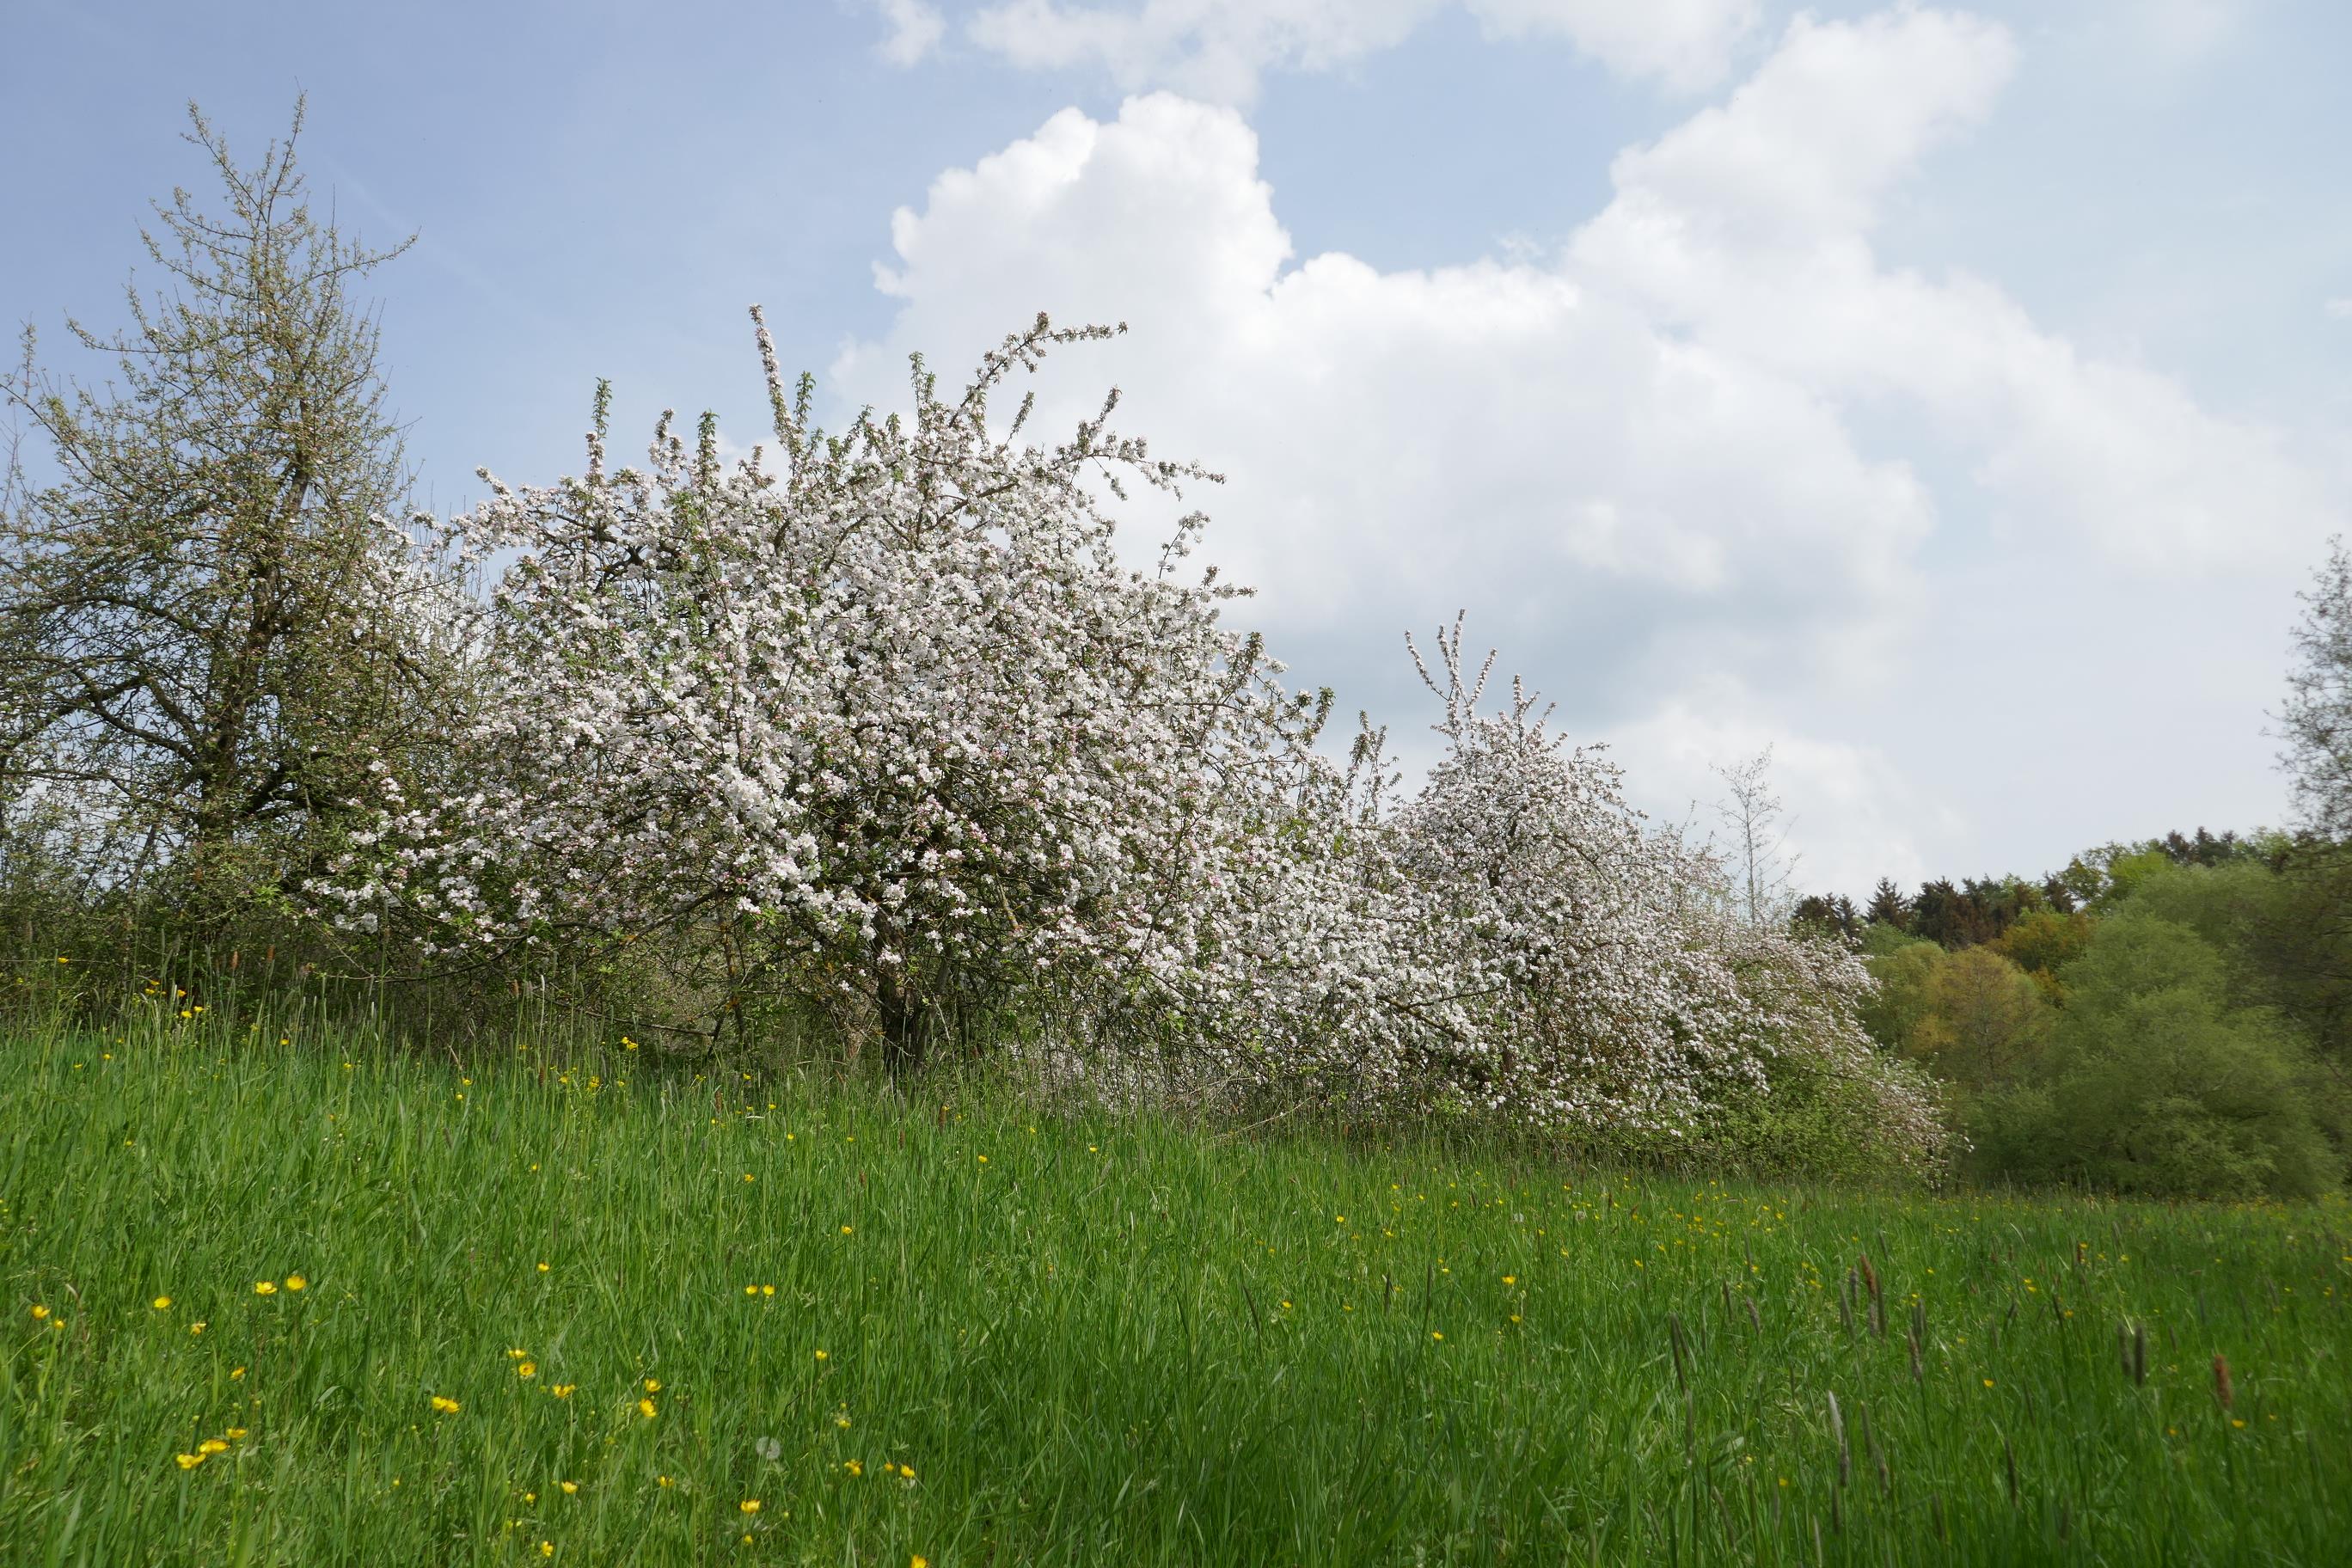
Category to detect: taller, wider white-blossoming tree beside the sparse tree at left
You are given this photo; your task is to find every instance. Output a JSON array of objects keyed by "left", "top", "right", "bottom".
[{"left": 332, "top": 317, "right": 1317, "bottom": 1060}]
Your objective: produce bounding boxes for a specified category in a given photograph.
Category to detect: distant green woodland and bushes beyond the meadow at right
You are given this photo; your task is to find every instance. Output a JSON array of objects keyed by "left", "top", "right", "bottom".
[{"left": 1795, "top": 828, "right": 2352, "bottom": 1197}]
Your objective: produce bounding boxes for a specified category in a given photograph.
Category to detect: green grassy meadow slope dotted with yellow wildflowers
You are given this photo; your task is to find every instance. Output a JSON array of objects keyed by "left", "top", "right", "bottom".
[{"left": 0, "top": 1011, "right": 2352, "bottom": 1568}]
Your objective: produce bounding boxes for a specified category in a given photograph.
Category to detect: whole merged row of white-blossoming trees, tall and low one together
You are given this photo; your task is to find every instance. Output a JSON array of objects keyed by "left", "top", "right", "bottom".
[{"left": 322, "top": 313, "right": 1933, "bottom": 1166}]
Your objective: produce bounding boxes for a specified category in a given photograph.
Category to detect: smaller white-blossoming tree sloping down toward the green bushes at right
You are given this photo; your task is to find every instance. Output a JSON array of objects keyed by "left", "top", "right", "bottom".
[{"left": 1172, "top": 621, "right": 1940, "bottom": 1159}]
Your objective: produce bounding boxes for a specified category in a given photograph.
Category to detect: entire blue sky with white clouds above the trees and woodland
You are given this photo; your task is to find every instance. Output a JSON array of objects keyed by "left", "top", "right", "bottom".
[{"left": 0, "top": 0, "right": 2352, "bottom": 893}]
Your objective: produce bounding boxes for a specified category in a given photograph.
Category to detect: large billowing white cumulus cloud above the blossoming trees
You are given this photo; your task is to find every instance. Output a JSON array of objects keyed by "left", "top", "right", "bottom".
[{"left": 833, "top": 4, "right": 2331, "bottom": 891}]
